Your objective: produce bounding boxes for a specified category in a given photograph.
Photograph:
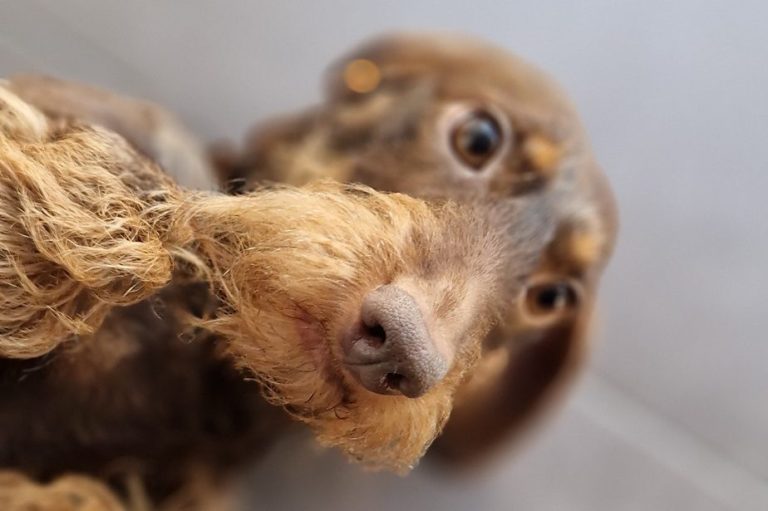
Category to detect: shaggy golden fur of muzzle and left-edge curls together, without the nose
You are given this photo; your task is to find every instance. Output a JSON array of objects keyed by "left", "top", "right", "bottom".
[{"left": 0, "top": 87, "right": 541, "bottom": 471}]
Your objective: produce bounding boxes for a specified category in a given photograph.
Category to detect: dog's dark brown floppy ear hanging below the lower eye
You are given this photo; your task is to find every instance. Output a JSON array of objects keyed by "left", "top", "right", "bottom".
[{"left": 433, "top": 303, "right": 591, "bottom": 466}]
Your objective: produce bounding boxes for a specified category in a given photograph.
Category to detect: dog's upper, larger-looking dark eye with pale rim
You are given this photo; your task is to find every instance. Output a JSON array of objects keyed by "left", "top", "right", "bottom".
[{"left": 451, "top": 111, "right": 502, "bottom": 170}]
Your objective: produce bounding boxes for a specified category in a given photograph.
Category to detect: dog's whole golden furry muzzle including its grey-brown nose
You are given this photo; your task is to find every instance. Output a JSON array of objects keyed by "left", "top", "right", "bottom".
[{"left": 190, "top": 185, "right": 551, "bottom": 470}]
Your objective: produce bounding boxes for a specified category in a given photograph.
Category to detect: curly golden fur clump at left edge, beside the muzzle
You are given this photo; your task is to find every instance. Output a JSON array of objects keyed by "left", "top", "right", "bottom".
[{"left": 0, "top": 88, "right": 188, "bottom": 358}]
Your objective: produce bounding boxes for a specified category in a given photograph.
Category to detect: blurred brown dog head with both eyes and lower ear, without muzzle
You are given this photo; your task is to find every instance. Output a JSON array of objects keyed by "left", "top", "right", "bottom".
[{"left": 214, "top": 35, "right": 616, "bottom": 464}]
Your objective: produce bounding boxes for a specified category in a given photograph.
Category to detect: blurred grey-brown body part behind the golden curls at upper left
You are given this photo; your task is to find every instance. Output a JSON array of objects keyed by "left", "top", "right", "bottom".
[{"left": 8, "top": 74, "right": 216, "bottom": 190}]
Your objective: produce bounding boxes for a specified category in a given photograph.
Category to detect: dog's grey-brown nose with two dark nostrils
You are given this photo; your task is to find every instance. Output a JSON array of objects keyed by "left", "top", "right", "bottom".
[{"left": 344, "top": 285, "right": 448, "bottom": 398}]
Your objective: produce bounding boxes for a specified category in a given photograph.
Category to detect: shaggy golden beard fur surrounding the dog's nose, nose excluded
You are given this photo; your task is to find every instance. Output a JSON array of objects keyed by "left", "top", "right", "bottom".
[{"left": 191, "top": 190, "right": 478, "bottom": 470}]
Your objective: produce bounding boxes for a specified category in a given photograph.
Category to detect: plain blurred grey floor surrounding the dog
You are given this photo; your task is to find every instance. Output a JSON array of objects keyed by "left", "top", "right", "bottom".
[{"left": 0, "top": 0, "right": 768, "bottom": 511}]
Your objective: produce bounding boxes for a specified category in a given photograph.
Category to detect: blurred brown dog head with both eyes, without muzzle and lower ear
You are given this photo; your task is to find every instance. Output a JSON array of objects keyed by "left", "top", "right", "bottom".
[{"left": 225, "top": 36, "right": 615, "bottom": 334}]
